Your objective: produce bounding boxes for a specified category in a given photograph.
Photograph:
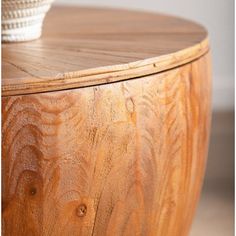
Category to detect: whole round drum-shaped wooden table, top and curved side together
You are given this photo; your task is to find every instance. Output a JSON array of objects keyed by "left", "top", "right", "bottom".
[{"left": 2, "top": 7, "right": 211, "bottom": 236}]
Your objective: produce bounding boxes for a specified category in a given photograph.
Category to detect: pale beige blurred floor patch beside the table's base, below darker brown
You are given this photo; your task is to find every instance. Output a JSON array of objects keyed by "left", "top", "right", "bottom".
[{"left": 190, "top": 187, "right": 234, "bottom": 236}]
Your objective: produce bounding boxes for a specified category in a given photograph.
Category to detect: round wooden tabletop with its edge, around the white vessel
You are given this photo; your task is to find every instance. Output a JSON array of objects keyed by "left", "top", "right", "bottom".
[{"left": 2, "top": 7, "right": 209, "bottom": 96}]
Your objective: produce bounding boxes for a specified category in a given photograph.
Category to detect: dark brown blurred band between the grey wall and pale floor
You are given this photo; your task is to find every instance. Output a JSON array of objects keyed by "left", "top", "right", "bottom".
[{"left": 203, "top": 110, "right": 234, "bottom": 193}]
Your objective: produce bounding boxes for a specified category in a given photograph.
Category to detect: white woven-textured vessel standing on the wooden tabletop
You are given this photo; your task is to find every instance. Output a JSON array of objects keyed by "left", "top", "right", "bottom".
[{"left": 2, "top": 0, "right": 54, "bottom": 42}]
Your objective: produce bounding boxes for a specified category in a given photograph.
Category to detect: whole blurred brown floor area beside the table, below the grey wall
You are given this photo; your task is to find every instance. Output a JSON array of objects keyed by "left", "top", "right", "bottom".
[{"left": 190, "top": 111, "right": 234, "bottom": 236}]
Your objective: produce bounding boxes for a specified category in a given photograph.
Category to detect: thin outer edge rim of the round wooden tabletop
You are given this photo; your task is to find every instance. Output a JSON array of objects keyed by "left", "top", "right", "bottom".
[{"left": 2, "top": 6, "right": 209, "bottom": 97}]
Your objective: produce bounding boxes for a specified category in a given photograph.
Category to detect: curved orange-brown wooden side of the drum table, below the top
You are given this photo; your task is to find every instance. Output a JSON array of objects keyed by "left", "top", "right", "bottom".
[{"left": 2, "top": 55, "right": 211, "bottom": 236}]
